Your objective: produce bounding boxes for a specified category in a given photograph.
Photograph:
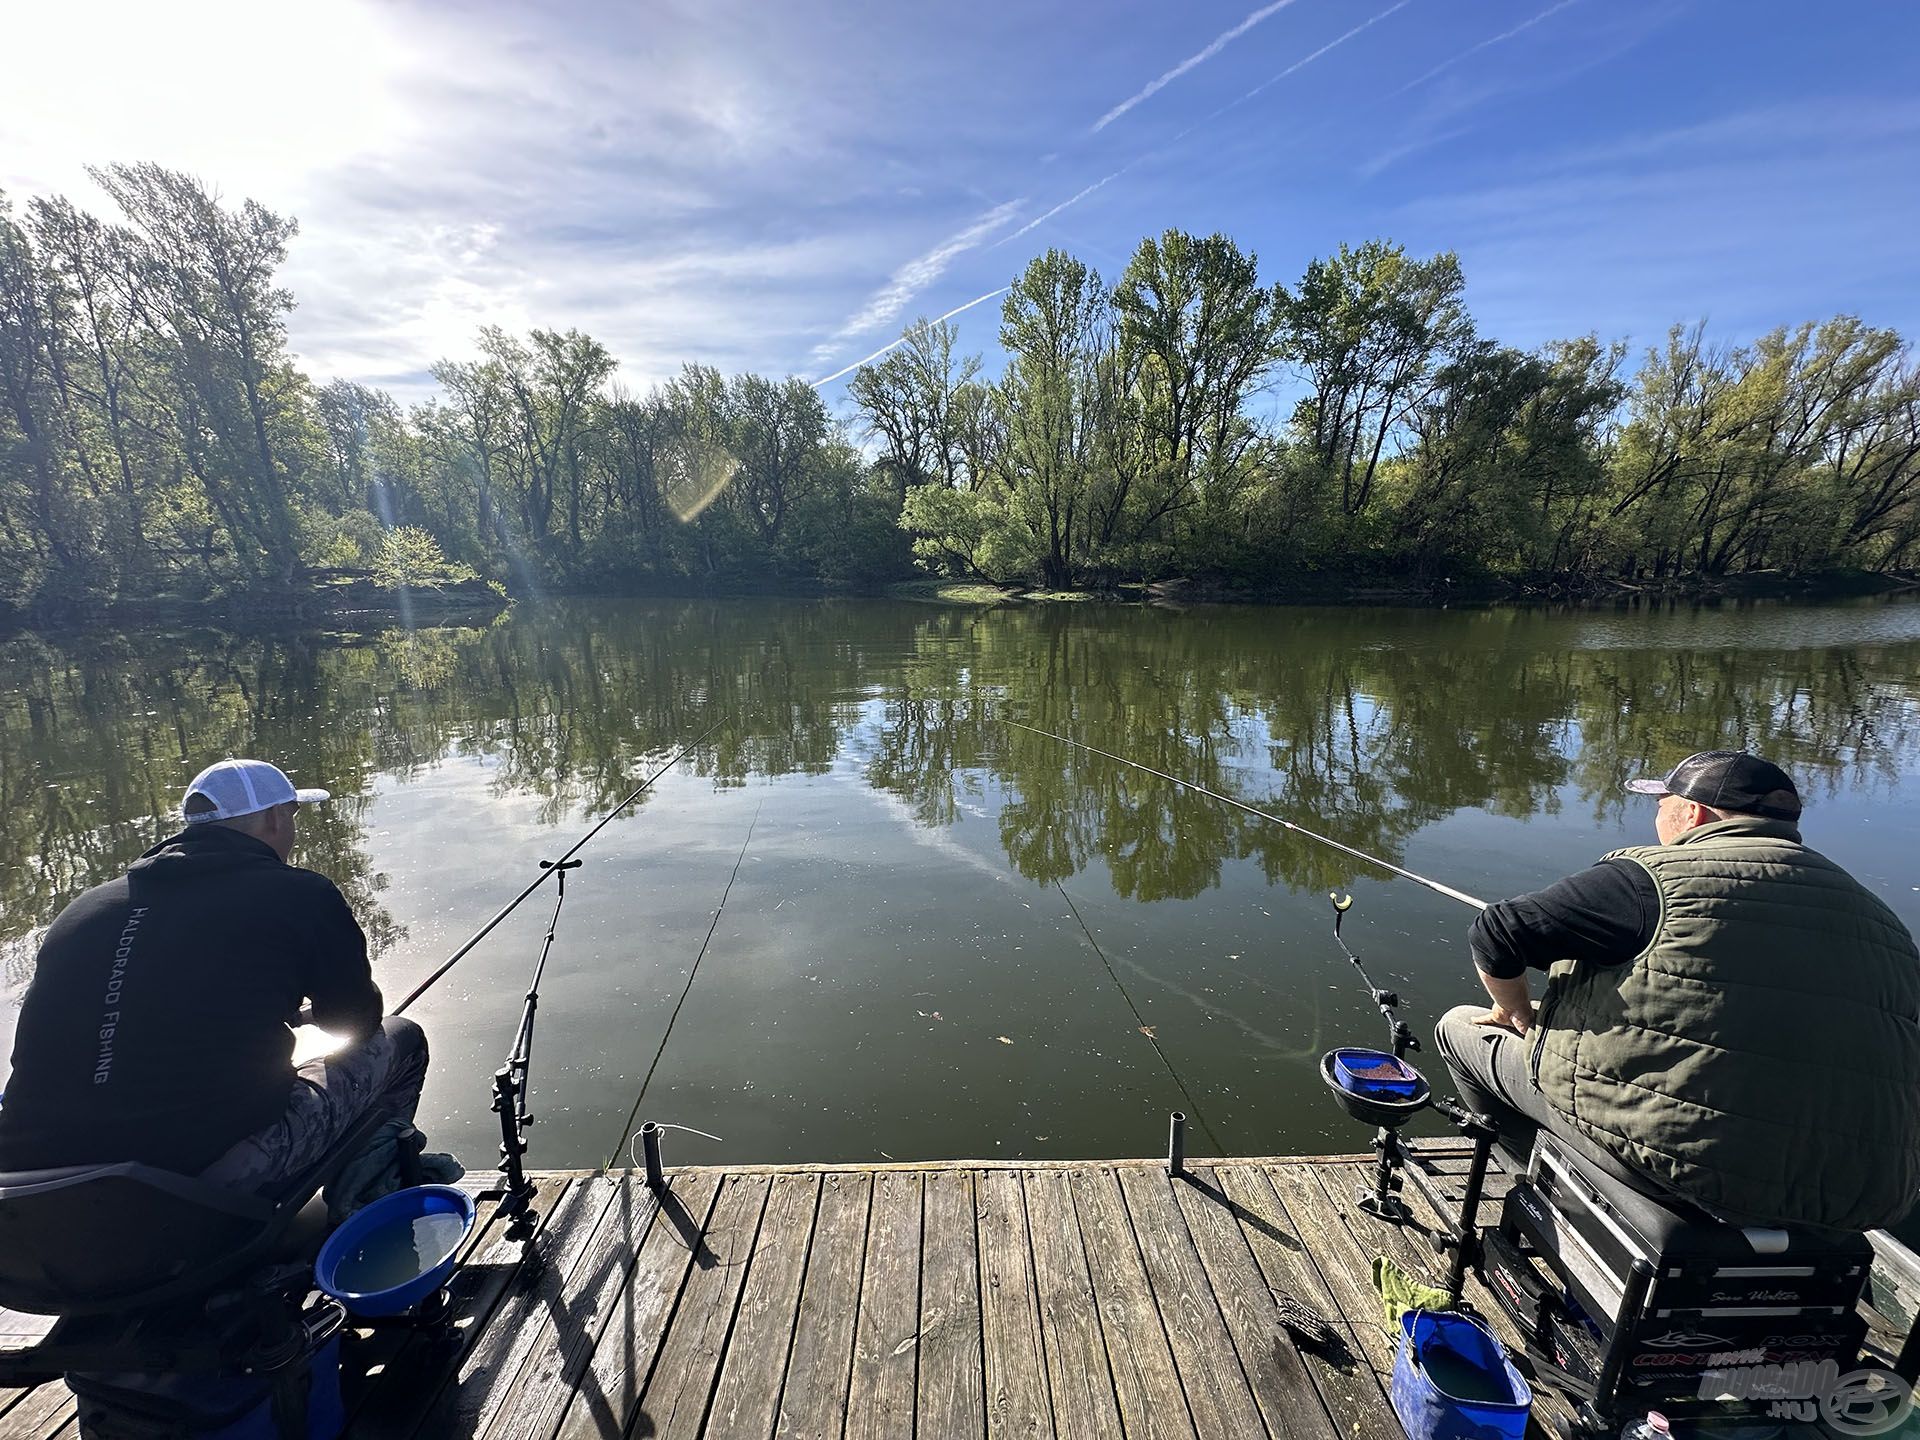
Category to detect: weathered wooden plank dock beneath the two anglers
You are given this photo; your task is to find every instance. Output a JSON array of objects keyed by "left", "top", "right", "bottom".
[{"left": 0, "top": 1146, "right": 1904, "bottom": 1440}]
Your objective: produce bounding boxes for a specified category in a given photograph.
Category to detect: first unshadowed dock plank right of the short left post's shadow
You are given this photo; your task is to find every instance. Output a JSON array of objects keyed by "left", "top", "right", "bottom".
[{"left": 707, "top": 1175, "right": 820, "bottom": 1440}]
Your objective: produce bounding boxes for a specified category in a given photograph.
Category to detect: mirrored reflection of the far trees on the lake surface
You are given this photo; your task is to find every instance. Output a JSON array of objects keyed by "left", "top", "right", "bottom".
[{"left": 0, "top": 601, "right": 1920, "bottom": 952}]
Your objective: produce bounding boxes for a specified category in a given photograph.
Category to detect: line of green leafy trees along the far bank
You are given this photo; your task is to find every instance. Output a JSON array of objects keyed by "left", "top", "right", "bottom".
[{"left": 0, "top": 165, "right": 1920, "bottom": 612}]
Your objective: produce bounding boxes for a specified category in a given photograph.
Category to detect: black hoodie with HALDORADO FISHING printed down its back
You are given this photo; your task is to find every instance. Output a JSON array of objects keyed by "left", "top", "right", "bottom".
[{"left": 0, "top": 826, "right": 382, "bottom": 1175}]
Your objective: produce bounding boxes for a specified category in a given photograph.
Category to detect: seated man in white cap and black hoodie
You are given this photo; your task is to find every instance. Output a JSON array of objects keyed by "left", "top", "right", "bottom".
[{"left": 0, "top": 760, "right": 426, "bottom": 1192}]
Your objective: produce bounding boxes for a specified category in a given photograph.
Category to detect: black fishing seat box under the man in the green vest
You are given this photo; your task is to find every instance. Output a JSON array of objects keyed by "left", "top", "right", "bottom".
[{"left": 1500, "top": 1131, "right": 1874, "bottom": 1413}]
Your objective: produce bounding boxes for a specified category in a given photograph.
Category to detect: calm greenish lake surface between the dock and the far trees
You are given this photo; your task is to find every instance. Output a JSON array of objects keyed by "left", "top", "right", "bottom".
[{"left": 0, "top": 601, "right": 1920, "bottom": 1165}]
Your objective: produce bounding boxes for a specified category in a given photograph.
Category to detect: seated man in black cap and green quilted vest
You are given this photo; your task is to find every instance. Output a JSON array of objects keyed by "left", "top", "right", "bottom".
[{"left": 1436, "top": 751, "right": 1920, "bottom": 1231}]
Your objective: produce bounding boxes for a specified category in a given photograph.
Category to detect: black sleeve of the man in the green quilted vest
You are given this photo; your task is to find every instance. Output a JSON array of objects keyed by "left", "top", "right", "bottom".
[{"left": 1467, "top": 860, "right": 1661, "bottom": 979}]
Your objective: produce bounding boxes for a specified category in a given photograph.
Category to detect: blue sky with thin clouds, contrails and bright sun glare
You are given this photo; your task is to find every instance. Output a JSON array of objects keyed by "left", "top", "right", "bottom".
[{"left": 0, "top": 0, "right": 1920, "bottom": 413}]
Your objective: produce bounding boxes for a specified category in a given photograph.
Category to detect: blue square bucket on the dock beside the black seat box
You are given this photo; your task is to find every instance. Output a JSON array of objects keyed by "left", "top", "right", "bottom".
[{"left": 1388, "top": 1309, "right": 1534, "bottom": 1440}]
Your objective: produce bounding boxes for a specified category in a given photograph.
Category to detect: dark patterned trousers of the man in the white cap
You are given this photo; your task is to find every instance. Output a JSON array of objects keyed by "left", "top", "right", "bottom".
[{"left": 200, "top": 1016, "right": 426, "bottom": 1194}]
